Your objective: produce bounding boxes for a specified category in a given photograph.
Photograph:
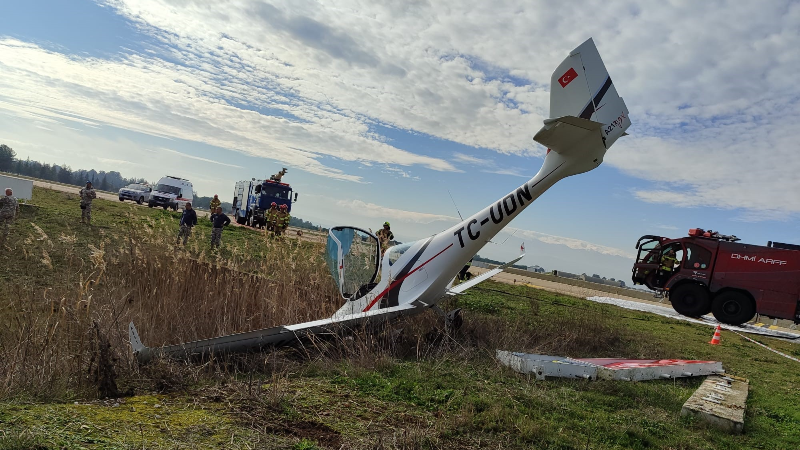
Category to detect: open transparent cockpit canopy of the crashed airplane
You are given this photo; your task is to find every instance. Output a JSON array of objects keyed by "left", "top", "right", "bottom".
[{"left": 325, "top": 227, "right": 380, "bottom": 298}]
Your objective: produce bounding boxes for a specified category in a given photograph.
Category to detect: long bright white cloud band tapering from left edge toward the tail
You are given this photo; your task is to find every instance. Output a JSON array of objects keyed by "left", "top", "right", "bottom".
[{"left": 0, "top": 39, "right": 455, "bottom": 181}]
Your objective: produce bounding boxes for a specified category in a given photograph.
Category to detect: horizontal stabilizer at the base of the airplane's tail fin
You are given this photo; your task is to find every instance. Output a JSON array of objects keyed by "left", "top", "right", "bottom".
[{"left": 533, "top": 116, "right": 603, "bottom": 155}]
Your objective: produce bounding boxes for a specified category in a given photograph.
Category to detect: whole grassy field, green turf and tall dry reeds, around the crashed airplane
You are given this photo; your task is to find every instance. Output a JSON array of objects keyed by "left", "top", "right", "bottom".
[{"left": 0, "top": 188, "right": 800, "bottom": 449}]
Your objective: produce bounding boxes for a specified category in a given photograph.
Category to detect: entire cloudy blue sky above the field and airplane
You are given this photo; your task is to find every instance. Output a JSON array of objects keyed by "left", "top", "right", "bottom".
[{"left": 0, "top": 0, "right": 800, "bottom": 281}]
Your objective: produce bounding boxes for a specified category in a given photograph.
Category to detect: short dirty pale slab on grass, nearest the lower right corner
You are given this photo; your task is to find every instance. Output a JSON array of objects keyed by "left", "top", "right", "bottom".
[{"left": 681, "top": 376, "right": 750, "bottom": 434}]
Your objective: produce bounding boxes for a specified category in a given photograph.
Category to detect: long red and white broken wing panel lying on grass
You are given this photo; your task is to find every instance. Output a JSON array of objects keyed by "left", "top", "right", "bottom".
[{"left": 497, "top": 350, "right": 725, "bottom": 381}]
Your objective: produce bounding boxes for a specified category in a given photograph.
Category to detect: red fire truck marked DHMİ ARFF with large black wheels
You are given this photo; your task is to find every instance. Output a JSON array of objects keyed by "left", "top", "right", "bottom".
[{"left": 633, "top": 228, "right": 800, "bottom": 325}]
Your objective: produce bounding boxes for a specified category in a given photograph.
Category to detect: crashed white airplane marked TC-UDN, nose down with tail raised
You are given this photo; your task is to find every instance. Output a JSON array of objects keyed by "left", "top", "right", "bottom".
[{"left": 129, "top": 39, "right": 631, "bottom": 363}]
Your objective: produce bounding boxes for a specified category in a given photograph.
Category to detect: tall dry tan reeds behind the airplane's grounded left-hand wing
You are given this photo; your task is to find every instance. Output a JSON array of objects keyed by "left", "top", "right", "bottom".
[{"left": 0, "top": 217, "right": 341, "bottom": 397}]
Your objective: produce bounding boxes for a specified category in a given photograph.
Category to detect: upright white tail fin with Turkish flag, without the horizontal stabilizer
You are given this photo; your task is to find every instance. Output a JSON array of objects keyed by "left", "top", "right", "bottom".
[{"left": 548, "top": 39, "right": 631, "bottom": 149}]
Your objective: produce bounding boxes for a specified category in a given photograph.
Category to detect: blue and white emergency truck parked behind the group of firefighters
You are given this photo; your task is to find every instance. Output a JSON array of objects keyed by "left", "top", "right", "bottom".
[{"left": 233, "top": 178, "right": 297, "bottom": 227}]
